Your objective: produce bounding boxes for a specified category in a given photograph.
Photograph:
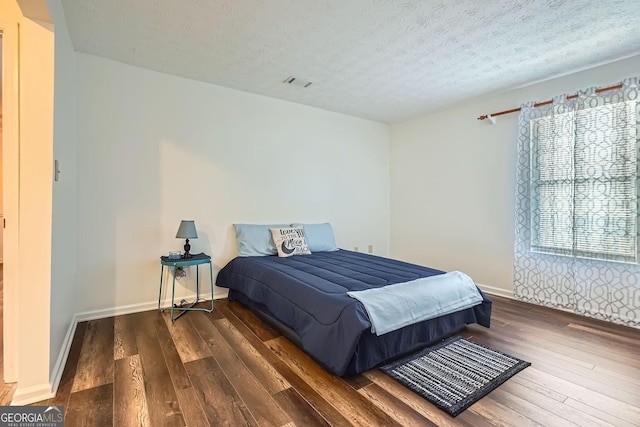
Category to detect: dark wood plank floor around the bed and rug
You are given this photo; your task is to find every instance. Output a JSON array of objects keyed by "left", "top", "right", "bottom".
[{"left": 35, "top": 297, "right": 640, "bottom": 427}]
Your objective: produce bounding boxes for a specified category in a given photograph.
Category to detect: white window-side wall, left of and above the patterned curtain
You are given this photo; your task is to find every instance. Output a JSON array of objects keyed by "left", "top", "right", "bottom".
[{"left": 391, "top": 56, "right": 640, "bottom": 294}]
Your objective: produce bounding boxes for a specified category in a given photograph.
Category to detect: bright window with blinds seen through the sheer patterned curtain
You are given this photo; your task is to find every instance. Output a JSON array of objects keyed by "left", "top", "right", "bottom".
[{"left": 530, "top": 101, "right": 638, "bottom": 262}]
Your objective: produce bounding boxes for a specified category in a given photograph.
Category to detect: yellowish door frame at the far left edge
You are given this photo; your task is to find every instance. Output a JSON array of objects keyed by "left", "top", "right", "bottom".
[{"left": 0, "top": 21, "right": 20, "bottom": 382}]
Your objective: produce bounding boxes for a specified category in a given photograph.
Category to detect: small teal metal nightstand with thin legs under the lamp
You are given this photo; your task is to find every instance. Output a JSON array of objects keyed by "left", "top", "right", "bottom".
[{"left": 158, "top": 253, "right": 213, "bottom": 322}]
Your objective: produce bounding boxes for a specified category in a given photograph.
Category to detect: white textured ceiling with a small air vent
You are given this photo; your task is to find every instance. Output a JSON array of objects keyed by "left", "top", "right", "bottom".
[{"left": 62, "top": 0, "right": 640, "bottom": 122}]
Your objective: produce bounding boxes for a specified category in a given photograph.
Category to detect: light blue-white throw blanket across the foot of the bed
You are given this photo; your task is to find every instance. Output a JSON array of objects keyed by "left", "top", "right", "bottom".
[{"left": 347, "top": 271, "right": 482, "bottom": 335}]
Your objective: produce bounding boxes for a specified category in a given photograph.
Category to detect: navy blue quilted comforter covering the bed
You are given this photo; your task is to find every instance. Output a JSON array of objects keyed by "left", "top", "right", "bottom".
[{"left": 216, "top": 249, "right": 491, "bottom": 376}]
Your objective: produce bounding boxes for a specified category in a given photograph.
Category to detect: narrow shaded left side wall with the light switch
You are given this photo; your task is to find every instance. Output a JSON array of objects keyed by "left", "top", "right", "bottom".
[{"left": 48, "top": 0, "right": 77, "bottom": 382}]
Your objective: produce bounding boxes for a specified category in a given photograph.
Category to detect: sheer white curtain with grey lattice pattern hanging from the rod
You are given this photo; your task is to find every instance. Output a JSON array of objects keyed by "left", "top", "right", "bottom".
[{"left": 514, "top": 78, "right": 640, "bottom": 328}]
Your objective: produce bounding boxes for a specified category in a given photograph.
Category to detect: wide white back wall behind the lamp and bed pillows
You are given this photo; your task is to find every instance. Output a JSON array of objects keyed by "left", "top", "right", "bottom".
[{"left": 76, "top": 53, "right": 389, "bottom": 311}]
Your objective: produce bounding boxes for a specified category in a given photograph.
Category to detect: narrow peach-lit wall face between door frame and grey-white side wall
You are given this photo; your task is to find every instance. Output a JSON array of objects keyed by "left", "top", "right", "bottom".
[{"left": 13, "top": 8, "right": 54, "bottom": 403}]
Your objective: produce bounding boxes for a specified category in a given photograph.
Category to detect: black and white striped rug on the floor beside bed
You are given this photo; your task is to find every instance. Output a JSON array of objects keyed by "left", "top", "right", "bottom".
[{"left": 381, "top": 337, "right": 531, "bottom": 416}]
